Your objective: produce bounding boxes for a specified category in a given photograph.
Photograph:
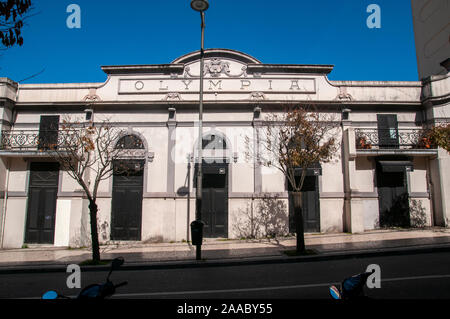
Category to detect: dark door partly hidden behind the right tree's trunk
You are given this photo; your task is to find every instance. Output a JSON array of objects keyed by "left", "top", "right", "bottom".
[{"left": 288, "top": 175, "right": 320, "bottom": 233}]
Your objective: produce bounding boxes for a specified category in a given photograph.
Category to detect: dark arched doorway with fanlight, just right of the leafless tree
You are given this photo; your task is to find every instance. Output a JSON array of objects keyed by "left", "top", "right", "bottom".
[{"left": 111, "top": 134, "right": 145, "bottom": 241}]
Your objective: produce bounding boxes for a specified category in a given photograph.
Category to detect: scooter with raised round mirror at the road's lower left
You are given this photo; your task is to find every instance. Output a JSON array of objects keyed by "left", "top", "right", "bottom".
[{"left": 42, "top": 257, "right": 128, "bottom": 300}]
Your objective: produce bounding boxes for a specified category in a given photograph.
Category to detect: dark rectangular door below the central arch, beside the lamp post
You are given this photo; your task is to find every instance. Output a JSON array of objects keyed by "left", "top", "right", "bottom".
[{"left": 201, "top": 166, "right": 228, "bottom": 238}]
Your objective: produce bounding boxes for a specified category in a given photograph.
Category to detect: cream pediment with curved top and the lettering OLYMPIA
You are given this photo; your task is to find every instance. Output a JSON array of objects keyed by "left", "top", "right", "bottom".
[{"left": 97, "top": 49, "right": 336, "bottom": 102}]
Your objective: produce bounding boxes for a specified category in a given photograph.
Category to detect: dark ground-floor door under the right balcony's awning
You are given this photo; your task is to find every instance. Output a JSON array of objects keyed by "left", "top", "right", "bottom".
[{"left": 377, "top": 167, "right": 410, "bottom": 227}]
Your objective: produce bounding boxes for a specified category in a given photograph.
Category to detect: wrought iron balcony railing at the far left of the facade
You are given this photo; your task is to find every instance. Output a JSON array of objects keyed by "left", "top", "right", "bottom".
[{"left": 0, "top": 130, "right": 77, "bottom": 151}]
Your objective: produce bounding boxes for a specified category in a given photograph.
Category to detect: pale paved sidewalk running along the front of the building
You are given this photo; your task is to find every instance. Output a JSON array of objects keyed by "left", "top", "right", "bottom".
[{"left": 0, "top": 228, "right": 450, "bottom": 272}]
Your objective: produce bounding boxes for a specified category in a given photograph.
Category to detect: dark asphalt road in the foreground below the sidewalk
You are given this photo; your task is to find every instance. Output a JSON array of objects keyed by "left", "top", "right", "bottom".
[{"left": 0, "top": 252, "right": 450, "bottom": 300}]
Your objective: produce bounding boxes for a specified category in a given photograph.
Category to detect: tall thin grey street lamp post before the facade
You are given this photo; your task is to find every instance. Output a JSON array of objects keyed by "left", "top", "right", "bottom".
[{"left": 191, "top": 0, "right": 209, "bottom": 260}]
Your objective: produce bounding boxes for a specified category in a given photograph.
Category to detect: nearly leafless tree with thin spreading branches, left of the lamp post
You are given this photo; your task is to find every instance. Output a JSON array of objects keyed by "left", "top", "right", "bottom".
[{"left": 45, "top": 119, "right": 141, "bottom": 263}]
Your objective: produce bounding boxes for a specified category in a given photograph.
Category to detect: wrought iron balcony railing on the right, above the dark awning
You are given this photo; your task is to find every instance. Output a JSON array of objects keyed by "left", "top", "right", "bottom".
[{"left": 355, "top": 128, "right": 436, "bottom": 150}]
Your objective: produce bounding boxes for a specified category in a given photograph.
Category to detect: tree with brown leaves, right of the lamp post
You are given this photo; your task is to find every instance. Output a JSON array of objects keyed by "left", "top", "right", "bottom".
[{"left": 247, "top": 106, "right": 339, "bottom": 253}]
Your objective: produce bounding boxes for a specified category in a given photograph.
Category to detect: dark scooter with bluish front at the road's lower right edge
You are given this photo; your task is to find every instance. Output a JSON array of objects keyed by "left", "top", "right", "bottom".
[{"left": 330, "top": 270, "right": 375, "bottom": 300}]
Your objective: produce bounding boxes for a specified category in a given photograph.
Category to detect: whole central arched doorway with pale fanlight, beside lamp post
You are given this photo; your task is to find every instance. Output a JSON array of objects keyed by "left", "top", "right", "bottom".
[{"left": 194, "top": 131, "right": 229, "bottom": 238}]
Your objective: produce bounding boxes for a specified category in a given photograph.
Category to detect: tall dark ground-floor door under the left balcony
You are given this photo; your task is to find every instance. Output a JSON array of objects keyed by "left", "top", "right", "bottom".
[{"left": 25, "top": 163, "right": 59, "bottom": 244}]
